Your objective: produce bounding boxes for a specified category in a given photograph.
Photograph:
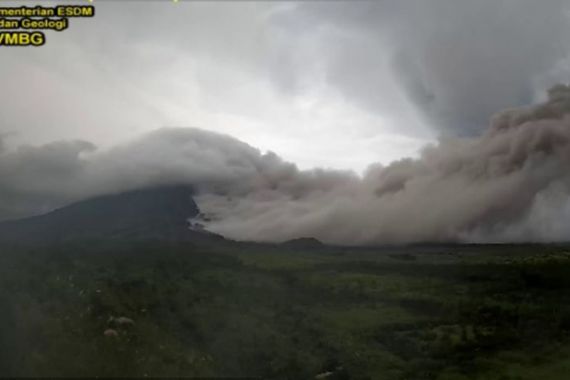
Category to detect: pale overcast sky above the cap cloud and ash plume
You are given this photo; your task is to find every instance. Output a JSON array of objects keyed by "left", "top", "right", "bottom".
[{"left": 0, "top": 0, "right": 570, "bottom": 171}]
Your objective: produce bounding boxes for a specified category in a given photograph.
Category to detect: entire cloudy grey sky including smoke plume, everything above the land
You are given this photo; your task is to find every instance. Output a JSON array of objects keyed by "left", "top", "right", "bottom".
[{"left": 0, "top": 0, "right": 570, "bottom": 244}]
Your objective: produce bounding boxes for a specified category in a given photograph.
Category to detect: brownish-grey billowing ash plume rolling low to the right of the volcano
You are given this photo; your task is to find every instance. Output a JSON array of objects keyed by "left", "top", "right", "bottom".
[{"left": 202, "top": 87, "right": 570, "bottom": 244}]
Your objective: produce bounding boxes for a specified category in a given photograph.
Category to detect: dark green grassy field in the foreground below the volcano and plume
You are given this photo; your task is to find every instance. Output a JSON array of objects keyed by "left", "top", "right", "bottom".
[{"left": 0, "top": 242, "right": 570, "bottom": 380}]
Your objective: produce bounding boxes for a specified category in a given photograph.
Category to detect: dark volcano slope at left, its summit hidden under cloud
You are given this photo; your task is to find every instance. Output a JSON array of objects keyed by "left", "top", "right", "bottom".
[{"left": 0, "top": 186, "right": 216, "bottom": 243}]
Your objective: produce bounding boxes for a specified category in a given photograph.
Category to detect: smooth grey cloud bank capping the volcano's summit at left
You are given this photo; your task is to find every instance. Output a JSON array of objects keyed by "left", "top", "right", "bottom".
[{"left": 0, "top": 128, "right": 357, "bottom": 219}]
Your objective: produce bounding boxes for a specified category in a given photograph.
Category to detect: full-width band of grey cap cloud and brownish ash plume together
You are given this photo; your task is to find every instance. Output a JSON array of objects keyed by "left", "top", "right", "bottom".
[{"left": 0, "top": 85, "right": 570, "bottom": 244}]
